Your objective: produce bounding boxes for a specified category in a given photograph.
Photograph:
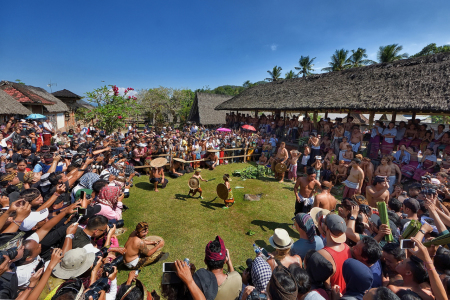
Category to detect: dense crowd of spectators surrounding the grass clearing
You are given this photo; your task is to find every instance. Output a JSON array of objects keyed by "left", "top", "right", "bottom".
[{"left": 0, "top": 115, "right": 450, "bottom": 300}]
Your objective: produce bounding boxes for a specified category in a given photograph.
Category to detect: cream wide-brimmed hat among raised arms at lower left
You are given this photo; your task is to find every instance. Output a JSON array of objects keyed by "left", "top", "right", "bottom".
[{"left": 53, "top": 248, "right": 95, "bottom": 279}]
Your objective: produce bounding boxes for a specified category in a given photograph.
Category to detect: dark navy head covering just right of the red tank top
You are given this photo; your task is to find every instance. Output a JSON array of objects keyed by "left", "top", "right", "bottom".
[{"left": 342, "top": 258, "right": 373, "bottom": 300}]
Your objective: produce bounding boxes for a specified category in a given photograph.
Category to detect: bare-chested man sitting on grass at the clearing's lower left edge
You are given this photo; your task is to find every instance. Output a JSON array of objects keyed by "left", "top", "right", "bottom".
[{"left": 124, "top": 222, "right": 169, "bottom": 270}]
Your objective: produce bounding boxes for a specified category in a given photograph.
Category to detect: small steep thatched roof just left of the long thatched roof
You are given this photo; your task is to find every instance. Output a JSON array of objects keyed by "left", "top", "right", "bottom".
[{"left": 188, "top": 93, "right": 232, "bottom": 125}]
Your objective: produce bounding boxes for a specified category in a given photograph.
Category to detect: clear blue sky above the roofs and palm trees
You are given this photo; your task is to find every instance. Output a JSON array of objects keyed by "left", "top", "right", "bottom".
[{"left": 0, "top": 0, "right": 450, "bottom": 95}]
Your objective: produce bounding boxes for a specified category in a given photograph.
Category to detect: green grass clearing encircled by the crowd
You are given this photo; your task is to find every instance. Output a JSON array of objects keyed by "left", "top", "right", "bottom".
[{"left": 118, "top": 163, "right": 299, "bottom": 291}]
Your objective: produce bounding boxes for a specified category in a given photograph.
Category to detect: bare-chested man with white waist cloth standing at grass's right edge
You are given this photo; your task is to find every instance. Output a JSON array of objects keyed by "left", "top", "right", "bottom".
[{"left": 294, "top": 167, "right": 320, "bottom": 215}]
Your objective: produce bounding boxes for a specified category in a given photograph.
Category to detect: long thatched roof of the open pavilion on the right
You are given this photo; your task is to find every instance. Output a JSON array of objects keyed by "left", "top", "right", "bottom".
[{"left": 216, "top": 52, "right": 450, "bottom": 113}]
